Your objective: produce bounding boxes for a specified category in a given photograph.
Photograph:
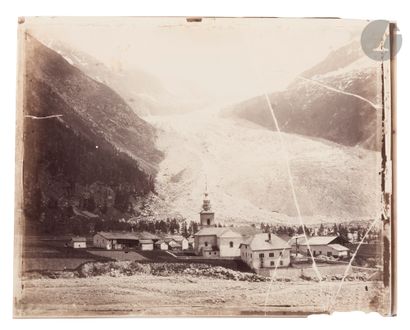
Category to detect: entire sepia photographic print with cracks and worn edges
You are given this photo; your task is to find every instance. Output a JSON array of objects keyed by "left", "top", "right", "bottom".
[{"left": 14, "top": 17, "right": 396, "bottom": 318}]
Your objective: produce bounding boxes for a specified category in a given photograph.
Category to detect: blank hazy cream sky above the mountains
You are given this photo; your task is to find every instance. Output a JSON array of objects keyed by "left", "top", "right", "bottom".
[{"left": 29, "top": 17, "right": 367, "bottom": 107}]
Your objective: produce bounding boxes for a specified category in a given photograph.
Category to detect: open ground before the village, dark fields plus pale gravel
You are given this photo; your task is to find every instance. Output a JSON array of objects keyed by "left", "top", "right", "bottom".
[{"left": 15, "top": 238, "right": 388, "bottom": 317}]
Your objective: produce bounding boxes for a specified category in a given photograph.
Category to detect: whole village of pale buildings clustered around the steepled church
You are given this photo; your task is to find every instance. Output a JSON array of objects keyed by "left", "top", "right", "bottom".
[{"left": 65, "top": 192, "right": 378, "bottom": 276}]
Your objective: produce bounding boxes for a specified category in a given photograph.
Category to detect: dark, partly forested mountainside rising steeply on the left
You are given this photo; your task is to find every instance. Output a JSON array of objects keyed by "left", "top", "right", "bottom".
[{"left": 23, "top": 34, "right": 163, "bottom": 230}]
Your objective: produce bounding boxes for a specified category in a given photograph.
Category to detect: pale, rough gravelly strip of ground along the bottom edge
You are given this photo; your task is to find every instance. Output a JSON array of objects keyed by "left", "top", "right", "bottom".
[{"left": 16, "top": 274, "right": 387, "bottom": 317}]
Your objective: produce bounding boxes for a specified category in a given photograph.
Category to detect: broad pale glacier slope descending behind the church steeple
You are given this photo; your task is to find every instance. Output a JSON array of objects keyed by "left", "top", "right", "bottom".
[{"left": 147, "top": 111, "right": 380, "bottom": 223}]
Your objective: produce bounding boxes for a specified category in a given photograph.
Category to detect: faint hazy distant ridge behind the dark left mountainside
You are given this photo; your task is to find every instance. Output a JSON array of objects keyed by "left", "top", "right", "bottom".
[{"left": 44, "top": 41, "right": 197, "bottom": 116}]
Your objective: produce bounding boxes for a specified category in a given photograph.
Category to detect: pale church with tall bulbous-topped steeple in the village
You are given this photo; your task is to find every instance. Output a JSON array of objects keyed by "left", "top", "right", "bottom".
[{"left": 194, "top": 192, "right": 260, "bottom": 258}]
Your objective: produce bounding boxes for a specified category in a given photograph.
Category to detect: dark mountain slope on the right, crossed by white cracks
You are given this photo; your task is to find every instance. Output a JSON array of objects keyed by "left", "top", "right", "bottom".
[{"left": 225, "top": 41, "right": 381, "bottom": 150}]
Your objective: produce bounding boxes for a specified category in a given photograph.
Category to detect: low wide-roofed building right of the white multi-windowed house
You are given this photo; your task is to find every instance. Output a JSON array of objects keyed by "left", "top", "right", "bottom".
[{"left": 297, "top": 236, "right": 350, "bottom": 258}]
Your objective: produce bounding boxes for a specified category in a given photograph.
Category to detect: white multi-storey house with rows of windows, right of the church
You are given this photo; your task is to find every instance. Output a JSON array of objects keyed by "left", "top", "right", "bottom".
[{"left": 240, "top": 233, "right": 291, "bottom": 271}]
